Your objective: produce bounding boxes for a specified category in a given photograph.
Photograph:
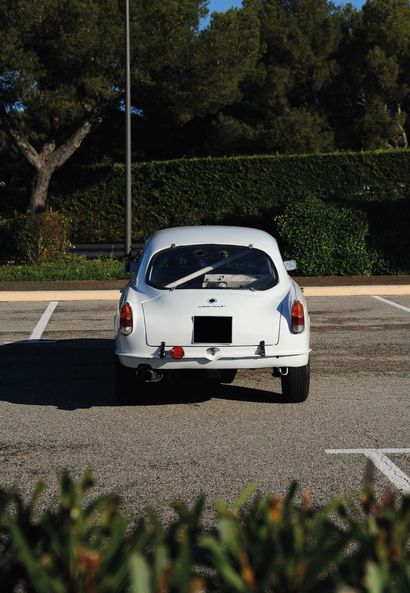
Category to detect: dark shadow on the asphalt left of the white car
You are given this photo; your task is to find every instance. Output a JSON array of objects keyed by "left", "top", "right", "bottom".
[{"left": 0, "top": 339, "right": 116, "bottom": 410}]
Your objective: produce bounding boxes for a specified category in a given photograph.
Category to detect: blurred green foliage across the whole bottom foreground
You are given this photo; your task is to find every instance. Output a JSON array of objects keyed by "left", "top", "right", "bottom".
[{"left": 0, "top": 472, "right": 410, "bottom": 593}]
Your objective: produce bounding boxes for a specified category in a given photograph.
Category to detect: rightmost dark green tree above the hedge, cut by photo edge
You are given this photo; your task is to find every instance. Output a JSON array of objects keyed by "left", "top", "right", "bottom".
[{"left": 328, "top": 0, "right": 410, "bottom": 149}]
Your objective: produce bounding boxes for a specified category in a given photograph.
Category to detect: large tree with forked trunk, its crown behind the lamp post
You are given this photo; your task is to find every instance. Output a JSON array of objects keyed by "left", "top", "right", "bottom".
[{"left": 0, "top": 0, "right": 259, "bottom": 211}]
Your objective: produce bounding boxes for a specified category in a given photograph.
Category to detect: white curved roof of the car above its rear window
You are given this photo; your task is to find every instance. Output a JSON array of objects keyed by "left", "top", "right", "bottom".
[{"left": 145, "top": 225, "right": 278, "bottom": 253}]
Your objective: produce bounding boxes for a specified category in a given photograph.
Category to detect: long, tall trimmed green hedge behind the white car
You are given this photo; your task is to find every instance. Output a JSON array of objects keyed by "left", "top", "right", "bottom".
[{"left": 45, "top": 150, "right": 410, "bottom": 242}]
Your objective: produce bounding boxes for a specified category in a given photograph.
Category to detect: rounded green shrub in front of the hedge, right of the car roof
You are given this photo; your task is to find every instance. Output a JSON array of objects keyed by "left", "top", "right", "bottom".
[{"left": 275, "top": 196, "right": 376, "bottom": 276}]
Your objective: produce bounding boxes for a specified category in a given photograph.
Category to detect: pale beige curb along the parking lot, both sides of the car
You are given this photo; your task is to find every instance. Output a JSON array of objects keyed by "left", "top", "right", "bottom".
[{"left": 0, "top": 284, "right": 410, "bottom": 302}]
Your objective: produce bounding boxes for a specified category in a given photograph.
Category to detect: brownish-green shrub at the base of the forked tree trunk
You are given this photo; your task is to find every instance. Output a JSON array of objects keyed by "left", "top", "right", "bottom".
[{"left": 12, "top": 210, "right": 71, "bottom": 264}]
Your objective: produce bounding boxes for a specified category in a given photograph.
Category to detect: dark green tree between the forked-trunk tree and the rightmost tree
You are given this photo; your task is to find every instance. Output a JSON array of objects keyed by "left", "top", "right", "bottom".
[{"left": 205, "top": 0, "right": 341, "bottom": 153}]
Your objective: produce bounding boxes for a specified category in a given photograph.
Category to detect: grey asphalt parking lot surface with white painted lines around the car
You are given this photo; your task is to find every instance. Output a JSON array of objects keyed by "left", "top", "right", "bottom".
[{"left": 0, "top": 290, "right": 410, "bottom": 518}]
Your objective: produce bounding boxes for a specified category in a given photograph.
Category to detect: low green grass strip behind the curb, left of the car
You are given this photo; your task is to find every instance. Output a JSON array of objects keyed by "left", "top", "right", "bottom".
[{"left": 0, "top": 255, "right": 129, "bottom": 282}]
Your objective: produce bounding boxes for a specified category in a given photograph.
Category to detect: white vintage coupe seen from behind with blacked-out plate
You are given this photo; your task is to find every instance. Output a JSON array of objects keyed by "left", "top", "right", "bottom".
[{"left": 114, "top": 226, "right": 310, "bottom": 402}]
